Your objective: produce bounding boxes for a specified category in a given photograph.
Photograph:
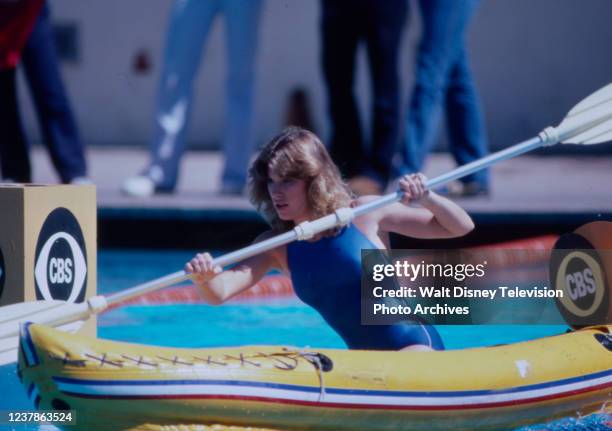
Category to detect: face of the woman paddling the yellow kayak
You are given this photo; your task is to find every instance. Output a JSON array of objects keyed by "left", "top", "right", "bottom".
[{"left": 268, "top": 173, "right": 309, "bottom": 223}]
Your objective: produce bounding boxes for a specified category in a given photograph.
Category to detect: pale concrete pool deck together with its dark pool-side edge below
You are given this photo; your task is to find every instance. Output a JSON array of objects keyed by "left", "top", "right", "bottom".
[{"left": 25, "top": 147, "right": 612, "bottom": 250}]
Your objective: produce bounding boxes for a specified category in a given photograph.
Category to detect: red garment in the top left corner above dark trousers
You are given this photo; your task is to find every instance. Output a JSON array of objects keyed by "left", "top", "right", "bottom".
[{"left": 0, "top": 0, "right": 44, "bottom": 70}]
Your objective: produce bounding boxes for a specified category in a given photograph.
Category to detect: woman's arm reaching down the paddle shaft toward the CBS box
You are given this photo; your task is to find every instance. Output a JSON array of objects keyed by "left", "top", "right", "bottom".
[{"left": 185, "top": 233, "right": 279, "bottom": 305}]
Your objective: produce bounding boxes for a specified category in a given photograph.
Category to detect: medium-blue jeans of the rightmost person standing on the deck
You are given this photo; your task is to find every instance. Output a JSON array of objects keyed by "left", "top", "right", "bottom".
[{"left": 400, "top": 0, "right": 488, "bottom": 187}]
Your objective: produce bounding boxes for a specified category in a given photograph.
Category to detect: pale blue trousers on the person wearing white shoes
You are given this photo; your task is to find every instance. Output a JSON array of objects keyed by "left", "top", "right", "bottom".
[{"left": 147, "top": 0, "right": 262, "bottom": 191}]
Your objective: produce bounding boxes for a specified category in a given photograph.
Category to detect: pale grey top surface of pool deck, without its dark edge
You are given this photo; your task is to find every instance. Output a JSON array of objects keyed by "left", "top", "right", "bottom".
[{"left": 33, "top": 147, "right": 612, "bottom": 215}]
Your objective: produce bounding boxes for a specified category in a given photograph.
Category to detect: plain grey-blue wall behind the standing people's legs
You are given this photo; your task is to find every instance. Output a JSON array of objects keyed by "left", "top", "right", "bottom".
[{"left": 16, "top": 0, "right": 612, "bottom": 152}]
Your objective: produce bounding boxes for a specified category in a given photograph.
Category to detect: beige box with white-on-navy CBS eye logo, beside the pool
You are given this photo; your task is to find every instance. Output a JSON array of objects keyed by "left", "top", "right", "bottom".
[{"left": 0, "top": 184, "right": 97, "bottom": 336}]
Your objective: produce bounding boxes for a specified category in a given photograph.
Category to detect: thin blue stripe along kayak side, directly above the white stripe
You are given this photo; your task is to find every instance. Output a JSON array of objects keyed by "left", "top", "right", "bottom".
[{"left": 53, "top": 369, "right": 612, "bottom": 398}]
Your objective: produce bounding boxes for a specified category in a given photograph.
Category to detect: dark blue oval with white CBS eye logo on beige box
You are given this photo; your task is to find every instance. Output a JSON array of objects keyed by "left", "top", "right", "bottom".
[{"left": 34, "top": 208, "right": 87, "bottom": 302}]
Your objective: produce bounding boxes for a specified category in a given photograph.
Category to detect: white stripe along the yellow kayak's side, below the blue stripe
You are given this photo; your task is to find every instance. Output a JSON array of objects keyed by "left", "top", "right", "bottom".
[{"left": 59, "top": 376, "right": 612, "bottom": 406}]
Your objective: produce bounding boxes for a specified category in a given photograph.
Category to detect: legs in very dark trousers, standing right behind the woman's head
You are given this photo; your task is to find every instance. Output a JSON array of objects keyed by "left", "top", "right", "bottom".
[{"left": 321, "top": 0, "right": 407, "bottom": 195}]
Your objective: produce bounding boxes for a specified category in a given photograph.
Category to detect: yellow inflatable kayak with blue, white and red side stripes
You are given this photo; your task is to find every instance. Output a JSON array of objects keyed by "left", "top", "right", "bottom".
[{"left": 18, "top": 324, "right": 612, "bottom": 430}]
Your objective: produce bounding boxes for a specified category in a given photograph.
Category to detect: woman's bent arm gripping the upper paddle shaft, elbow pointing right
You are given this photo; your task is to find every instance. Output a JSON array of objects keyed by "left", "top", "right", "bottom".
[{"left": 378, "top": 174, "right": 474, "bottom": 239}]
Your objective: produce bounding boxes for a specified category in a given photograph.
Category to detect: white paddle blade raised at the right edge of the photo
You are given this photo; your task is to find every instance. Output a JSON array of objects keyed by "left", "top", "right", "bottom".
[{"left": 556, "top": 84, "right": 612, "bottom": 145}]
